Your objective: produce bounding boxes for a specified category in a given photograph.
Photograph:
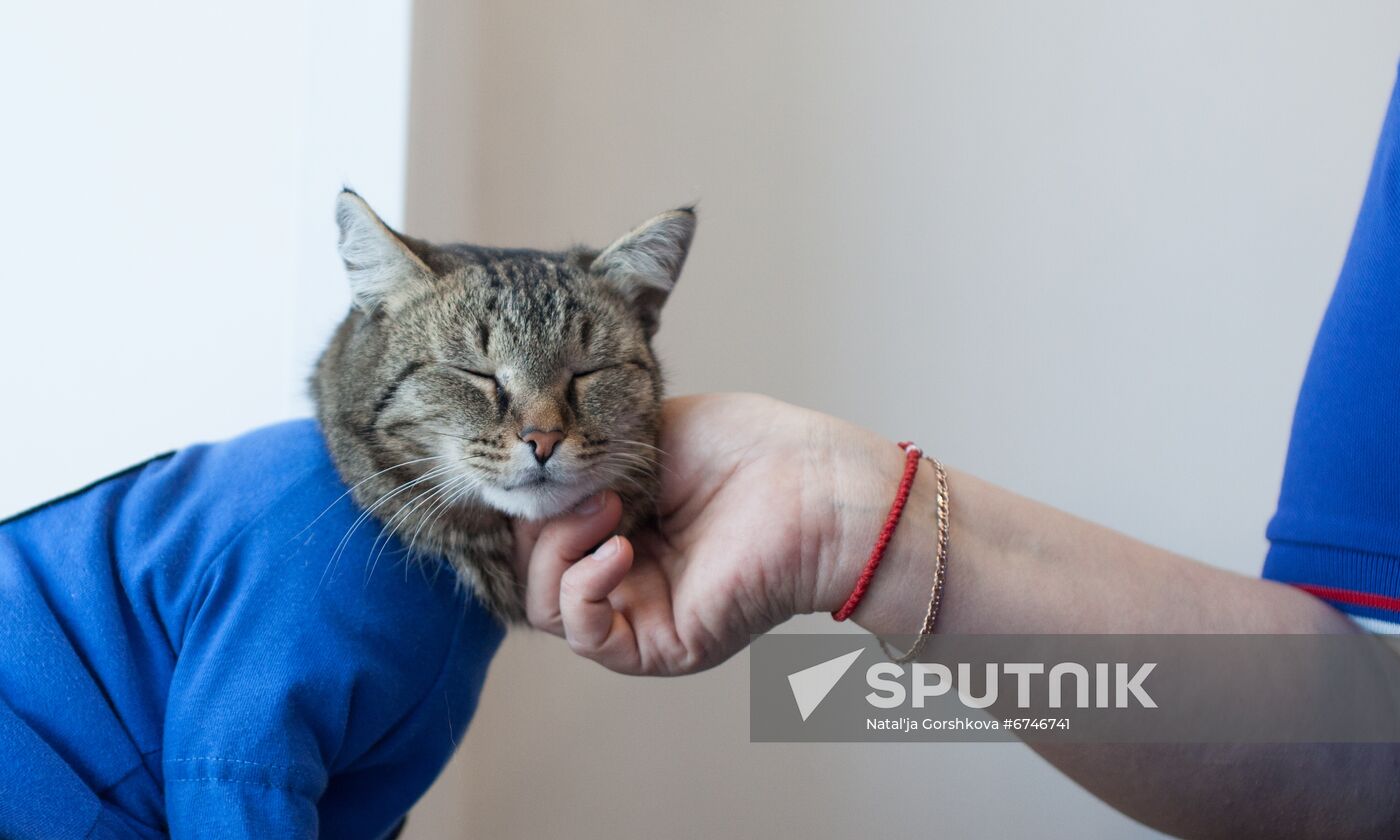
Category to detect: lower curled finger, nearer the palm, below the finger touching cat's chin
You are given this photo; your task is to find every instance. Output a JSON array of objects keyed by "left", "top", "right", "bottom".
[{"left": 559, "top": 536, "right": 641, "bottom": 673}]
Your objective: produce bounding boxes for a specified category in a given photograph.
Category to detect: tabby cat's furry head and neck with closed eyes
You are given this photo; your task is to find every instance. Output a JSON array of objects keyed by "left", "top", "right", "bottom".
[{"left": 311, "top": 189, "right": 696, "bottom": 623}]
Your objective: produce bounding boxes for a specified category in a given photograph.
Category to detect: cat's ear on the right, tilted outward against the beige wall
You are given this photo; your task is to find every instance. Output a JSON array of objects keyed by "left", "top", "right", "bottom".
[{"left": 588, "top": 207, "right": 696, "bottom": 335}]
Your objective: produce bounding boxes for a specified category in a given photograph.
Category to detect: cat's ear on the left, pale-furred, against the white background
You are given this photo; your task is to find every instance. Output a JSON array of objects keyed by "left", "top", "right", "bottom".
[{"left": 336, "top": 189, "right": 433, "bottom": 312}]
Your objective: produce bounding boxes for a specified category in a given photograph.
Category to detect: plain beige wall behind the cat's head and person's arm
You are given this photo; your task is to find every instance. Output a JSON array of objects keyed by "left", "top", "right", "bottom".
[{"left": 407, "top": 0, "right": 1400, "bottom": 840}]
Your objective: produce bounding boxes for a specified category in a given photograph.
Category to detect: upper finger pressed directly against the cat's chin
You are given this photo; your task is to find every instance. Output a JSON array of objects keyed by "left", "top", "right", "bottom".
[{"left": 525, "top": 491, "right": 622, "bottom": 636}]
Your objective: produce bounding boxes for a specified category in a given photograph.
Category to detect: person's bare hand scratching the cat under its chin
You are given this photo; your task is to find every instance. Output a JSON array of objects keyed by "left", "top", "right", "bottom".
[{"left": 517, "top": 395, "right": 903, "bottom": 675}]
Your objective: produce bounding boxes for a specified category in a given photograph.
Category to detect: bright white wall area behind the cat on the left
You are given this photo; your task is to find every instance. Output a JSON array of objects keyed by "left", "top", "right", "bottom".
[{"left": 0, "top": 0, "right": 410, "bottom": 515}]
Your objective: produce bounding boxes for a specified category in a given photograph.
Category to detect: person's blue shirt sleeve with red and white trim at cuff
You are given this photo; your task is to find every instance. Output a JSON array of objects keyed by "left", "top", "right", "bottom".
[{"left": 1264, "top": 65, "right": 1400, "bottom": 630}]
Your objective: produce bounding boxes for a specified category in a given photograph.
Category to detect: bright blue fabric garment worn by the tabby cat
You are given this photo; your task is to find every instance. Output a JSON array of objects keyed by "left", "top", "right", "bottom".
[{"left": 0, "top": 420, "right": 504, "bottom": 840}]
